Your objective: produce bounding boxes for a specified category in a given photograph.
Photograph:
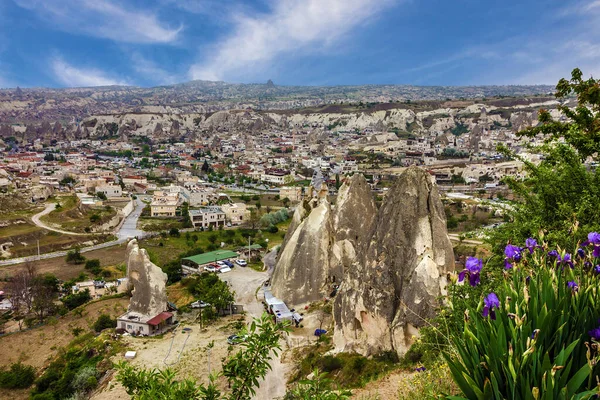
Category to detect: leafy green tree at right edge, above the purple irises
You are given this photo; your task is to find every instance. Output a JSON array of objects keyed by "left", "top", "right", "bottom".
[{"left": 490, "top": 69, "right": 600, "bottom": 251}]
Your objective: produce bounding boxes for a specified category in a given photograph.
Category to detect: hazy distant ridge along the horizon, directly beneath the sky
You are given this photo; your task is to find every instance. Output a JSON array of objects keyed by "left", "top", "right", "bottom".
[{"left": 0, "top": 80, "right": 554, "bottom": 123}]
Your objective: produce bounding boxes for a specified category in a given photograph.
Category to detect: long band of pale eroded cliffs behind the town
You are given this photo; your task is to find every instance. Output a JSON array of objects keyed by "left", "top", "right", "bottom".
[{"left": 0, "top": 97, "right": 558, "bottom": 144}]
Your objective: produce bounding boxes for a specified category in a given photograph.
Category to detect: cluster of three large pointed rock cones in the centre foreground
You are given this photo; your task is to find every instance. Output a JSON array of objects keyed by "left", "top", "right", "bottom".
[{"left": 271, "top": 167, "right": 454, "bottom": 355}]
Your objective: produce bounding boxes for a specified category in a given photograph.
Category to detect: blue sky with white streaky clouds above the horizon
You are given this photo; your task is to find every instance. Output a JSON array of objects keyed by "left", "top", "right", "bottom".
[{"left": 0, "top": 0, "right": 600, "bottom": 87}]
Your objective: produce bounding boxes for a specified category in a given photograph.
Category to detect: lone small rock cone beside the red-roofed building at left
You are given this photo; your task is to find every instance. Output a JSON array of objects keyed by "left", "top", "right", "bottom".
[{"left": 127, "top": 239, "right": 167, "bottom": 317}]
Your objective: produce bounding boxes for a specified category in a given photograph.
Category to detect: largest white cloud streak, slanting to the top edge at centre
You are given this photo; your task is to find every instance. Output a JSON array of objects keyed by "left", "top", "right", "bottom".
[{"left": 189, "top": 0, "right": 397, "bottom": 80}]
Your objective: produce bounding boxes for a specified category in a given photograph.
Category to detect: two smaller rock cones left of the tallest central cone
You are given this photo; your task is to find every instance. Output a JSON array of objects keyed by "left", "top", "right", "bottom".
[{"left": 271, "top": 174, "right": 376, "bottom": 305}]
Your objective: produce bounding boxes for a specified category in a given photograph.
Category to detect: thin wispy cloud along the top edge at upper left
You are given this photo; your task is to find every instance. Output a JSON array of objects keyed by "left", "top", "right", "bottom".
[{"left": 15, "top": 0, "right": 183, "bottom": 43}]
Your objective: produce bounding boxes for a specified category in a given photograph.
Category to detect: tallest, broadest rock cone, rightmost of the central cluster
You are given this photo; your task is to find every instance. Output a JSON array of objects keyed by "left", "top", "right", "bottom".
[{"left": 334, "top": 167, "right": 454, "bottom": 355}]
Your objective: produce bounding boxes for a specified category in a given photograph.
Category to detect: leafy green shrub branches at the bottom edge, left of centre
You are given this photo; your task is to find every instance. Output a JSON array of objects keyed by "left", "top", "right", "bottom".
[{"left": 117, "top": 314, "right": 289, "bottom": 400}]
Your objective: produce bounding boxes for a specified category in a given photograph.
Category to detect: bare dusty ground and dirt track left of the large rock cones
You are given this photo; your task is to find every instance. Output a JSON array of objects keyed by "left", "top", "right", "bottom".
[{"left": 92, "top": 267, "right": 330, "bottom": 400}]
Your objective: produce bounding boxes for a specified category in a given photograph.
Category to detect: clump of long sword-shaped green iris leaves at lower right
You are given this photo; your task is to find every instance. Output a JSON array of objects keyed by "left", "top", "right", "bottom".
[{"left": 444, "top": 241, "right": 600, "bottom": 400}]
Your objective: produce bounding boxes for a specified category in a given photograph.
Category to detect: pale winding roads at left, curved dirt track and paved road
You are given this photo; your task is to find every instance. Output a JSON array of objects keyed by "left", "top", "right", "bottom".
[{"left": 0, "top": 198, "right": 145, "bottom": 266}]
